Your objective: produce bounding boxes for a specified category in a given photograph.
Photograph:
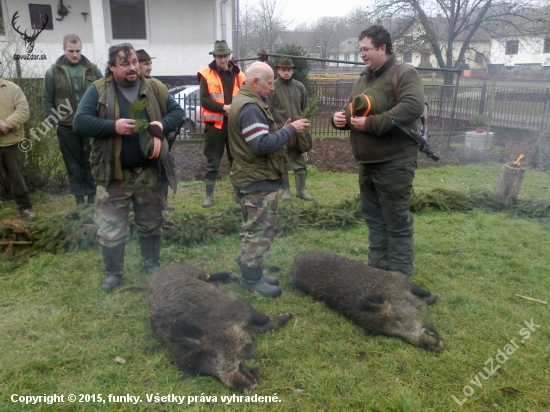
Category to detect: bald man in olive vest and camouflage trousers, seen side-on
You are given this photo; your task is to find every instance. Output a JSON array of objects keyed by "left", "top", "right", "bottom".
[{"left": 228, "top": 62, "right": 309, "bottom": 297}]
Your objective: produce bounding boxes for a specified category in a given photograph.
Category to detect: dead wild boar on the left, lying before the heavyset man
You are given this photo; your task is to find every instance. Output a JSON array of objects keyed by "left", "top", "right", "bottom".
[{"left": 147, "top": 263, "right": 292, "bottom": 391}]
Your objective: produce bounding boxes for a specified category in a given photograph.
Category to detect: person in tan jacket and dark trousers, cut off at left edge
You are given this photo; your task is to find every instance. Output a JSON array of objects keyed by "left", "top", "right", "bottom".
[{"left": 0, "top": 79, "right": 36, "bottom": 220}]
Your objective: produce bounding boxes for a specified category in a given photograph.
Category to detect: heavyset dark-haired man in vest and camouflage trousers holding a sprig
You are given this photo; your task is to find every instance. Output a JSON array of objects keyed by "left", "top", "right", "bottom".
[{"left": 74, "top": 43, "right": 184, "bottom": 292}]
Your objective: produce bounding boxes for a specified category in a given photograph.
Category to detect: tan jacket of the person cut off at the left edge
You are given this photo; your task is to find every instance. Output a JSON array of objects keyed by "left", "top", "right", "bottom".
[{"left": 0, "top": 79, "right": 29, "bottom": 147}]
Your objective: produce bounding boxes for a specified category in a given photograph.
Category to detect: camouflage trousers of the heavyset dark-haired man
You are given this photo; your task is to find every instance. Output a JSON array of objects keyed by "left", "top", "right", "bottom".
[{"left": 94, "top": 166, "right": 164, "bottom": 247}]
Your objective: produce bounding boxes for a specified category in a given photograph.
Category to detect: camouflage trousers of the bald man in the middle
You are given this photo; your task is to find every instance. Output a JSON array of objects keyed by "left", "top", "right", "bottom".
[{"left": 237, "top": 191, "right": 279, "bottom": 268}]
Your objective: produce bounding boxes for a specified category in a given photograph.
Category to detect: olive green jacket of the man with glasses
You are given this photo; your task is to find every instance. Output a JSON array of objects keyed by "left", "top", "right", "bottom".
[{"left": 341, "top": 56, "right": 424, "bottom": 163}]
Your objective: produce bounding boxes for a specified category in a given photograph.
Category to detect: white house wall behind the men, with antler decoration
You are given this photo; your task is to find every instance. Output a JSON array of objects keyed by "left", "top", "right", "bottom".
[{"left": 0, "top": 0, "right": 233, "bottom": 77}]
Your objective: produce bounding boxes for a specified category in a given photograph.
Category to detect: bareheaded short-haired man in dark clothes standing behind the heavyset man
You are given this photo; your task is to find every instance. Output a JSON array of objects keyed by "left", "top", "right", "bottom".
[{"left": 42, "top": 34, "right": 103, "bottom": 205}]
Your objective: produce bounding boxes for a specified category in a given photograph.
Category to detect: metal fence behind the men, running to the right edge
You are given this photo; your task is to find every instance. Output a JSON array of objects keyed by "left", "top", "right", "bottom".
[{"left": 172, "top": 80, "right": 550, "bottom": 138}]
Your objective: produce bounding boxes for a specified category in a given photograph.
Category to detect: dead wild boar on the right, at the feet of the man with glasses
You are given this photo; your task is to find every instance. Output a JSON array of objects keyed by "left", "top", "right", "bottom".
[{"left": 292, "top": 251, "right": 443, "bottom": 352}]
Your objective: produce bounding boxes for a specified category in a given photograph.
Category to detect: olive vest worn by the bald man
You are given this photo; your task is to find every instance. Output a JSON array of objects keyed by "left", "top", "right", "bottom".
[{"left": 229, "top": 86, "right": 285, "bottom": 189}]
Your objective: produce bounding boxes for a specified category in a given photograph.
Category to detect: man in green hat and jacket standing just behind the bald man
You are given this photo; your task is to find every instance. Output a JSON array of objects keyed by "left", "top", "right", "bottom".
[{"left": 267, "top": 56, "right": 313, "bottom": 200}]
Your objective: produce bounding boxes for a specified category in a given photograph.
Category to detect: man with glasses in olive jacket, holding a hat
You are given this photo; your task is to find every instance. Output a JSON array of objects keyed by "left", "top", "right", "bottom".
[{"left": 332, "top": 26, "right": 424, "bottom": 276}]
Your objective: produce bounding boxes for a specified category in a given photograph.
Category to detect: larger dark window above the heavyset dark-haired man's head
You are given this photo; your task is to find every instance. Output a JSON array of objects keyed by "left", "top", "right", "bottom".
[{"left": 110, "top": 0, "right": 147, "bottom": 40}]
